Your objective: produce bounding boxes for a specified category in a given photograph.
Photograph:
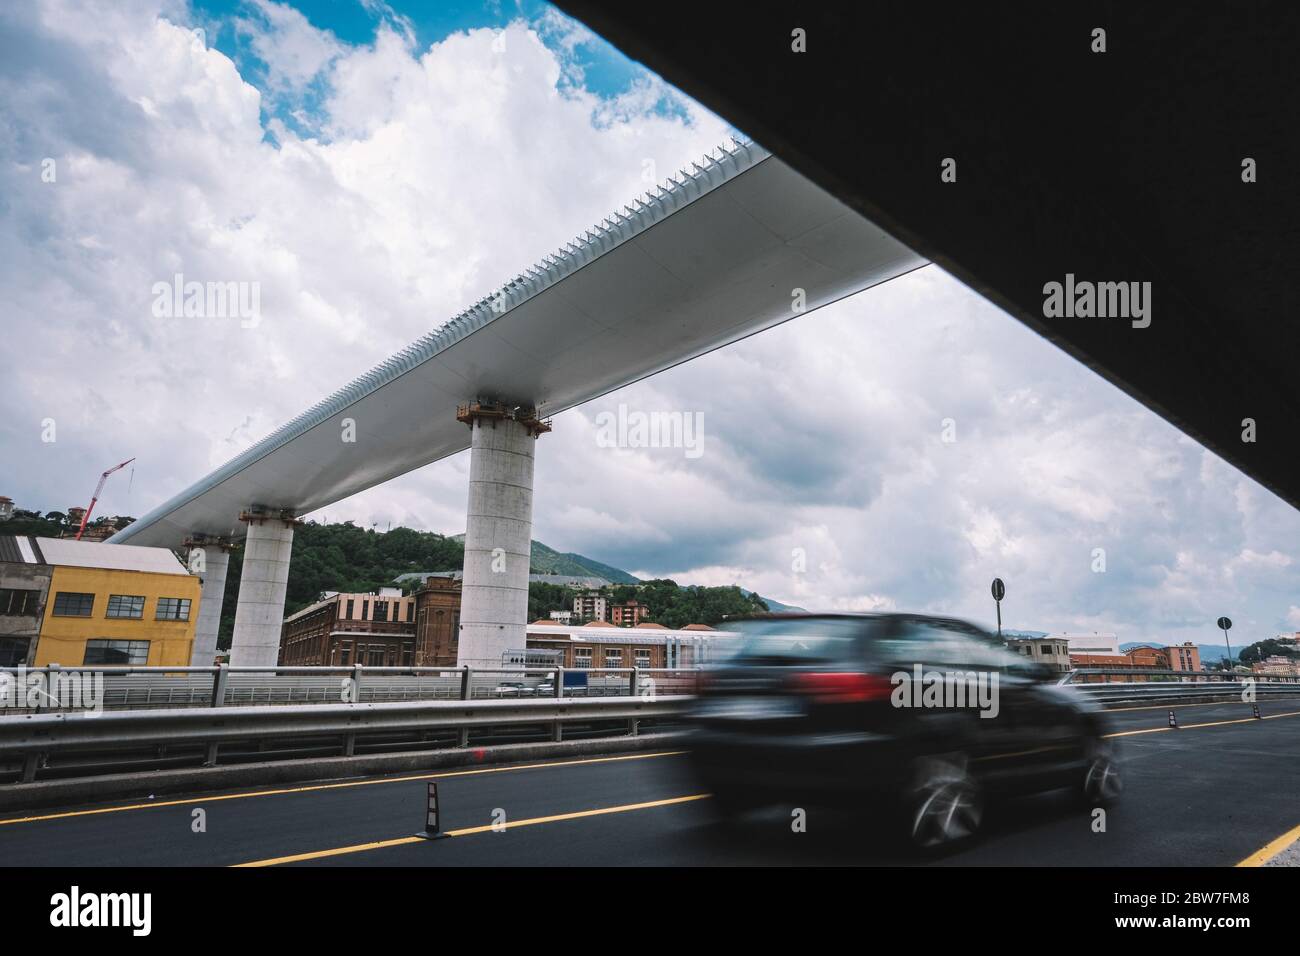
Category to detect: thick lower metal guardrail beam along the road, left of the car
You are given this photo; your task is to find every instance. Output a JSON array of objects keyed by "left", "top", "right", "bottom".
[{"left": 0, "top": 696, "right": 689, "bottom": 783}]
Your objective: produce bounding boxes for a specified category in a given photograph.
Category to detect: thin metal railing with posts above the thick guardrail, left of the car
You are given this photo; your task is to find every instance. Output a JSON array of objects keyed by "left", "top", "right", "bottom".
[{"left": 0, "top": 665, "right": 698, "bottom": 722}]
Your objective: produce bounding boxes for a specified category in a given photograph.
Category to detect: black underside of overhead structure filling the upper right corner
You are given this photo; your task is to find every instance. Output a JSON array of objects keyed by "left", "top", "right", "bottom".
[{"left": 558, "top": 0, "right": 1300, "bottom": 506}]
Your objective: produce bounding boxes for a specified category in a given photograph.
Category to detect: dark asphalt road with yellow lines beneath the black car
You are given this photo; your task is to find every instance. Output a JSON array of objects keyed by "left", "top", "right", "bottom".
[{"left": 0, "top": 701, "right": 1300, "bottom": 866}]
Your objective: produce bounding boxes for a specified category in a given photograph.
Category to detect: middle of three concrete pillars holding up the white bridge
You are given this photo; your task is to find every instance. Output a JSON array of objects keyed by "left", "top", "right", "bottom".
[{"left": 230, "top": 509, "right": 296, "bottom": 667}]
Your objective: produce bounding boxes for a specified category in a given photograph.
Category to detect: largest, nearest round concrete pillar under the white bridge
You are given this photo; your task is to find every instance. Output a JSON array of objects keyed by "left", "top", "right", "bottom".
[{"left": 456, "top": 402, "right": 550, "bottom": 667}]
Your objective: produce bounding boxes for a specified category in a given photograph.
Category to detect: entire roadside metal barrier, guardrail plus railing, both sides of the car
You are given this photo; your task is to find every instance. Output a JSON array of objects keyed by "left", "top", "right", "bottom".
[{"left": 0, "top": 666, "right": 1300, "bottom": 783}]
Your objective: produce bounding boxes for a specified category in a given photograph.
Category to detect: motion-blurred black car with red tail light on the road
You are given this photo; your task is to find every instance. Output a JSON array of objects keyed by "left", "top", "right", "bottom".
[{"left": 689, "top": 614, "right": 1122, "bottom": 848}]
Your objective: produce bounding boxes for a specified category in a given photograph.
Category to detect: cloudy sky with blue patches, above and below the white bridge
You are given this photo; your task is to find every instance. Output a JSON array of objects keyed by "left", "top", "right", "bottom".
[{"left": 0, "top": 0, "right": 1300, "bottom": 643}]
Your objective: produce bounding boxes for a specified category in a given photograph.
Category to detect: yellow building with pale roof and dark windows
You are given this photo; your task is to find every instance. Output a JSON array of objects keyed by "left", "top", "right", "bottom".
[{"left": 33, "top": 537, "right": 202, "bottom": 667}]
